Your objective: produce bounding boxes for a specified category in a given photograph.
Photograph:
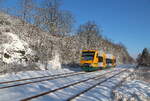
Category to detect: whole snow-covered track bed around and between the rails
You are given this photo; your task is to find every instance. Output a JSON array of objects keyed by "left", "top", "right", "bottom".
[{"left": 0, "top": 65, "right": 148, "bottom": 101}]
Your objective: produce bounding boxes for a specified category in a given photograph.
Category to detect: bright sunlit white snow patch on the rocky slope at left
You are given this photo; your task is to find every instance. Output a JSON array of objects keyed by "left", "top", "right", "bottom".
[{"left": 1, "top": 32, "right": 34, "bottom": 63}]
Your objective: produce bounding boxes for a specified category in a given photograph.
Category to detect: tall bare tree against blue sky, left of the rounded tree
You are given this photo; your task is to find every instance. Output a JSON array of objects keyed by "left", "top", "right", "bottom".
[{"left": 35, "top": 0, "right": 74, "bottom": 35}]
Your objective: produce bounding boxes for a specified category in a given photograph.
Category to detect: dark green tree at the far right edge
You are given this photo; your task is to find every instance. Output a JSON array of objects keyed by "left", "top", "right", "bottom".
[{"left": 137, "top": 48, "right": 150, "bottom": 66}]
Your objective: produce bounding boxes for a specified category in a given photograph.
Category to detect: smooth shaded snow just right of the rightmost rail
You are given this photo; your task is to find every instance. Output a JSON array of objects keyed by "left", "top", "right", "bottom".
[{"left": 75, "top": 72, "right": 128, "bottom": 101}]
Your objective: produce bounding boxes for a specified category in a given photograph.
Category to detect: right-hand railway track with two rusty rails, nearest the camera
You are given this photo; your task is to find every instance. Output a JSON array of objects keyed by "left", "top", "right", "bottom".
[{"left": 21, "top": 69, "right": 127, "bottom": 101}]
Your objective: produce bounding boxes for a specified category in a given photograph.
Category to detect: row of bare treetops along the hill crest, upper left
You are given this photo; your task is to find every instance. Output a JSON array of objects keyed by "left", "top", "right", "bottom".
[{"left": 0, "top": 0, "right": 75, "bottom": 35}]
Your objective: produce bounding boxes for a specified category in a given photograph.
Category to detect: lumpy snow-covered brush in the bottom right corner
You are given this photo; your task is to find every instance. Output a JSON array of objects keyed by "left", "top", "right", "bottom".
[{"left": 114, "top": 80, "right": 150, "bottom": 101}]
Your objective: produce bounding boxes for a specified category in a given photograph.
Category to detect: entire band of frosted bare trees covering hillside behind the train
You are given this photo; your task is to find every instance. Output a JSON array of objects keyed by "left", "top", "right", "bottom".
[{"left": 0, "top": 0, "right": 133, "bottom": 64}]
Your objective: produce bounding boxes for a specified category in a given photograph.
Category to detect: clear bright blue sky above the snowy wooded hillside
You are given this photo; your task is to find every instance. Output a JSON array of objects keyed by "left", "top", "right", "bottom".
[{"left": 1, "top": 0, "right": 150, "bottom": 57}]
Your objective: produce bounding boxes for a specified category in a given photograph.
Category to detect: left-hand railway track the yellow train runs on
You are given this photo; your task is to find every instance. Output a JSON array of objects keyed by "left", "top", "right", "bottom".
[{"left": 0, "top": 72, "right": 87, "bottom": 89}]
